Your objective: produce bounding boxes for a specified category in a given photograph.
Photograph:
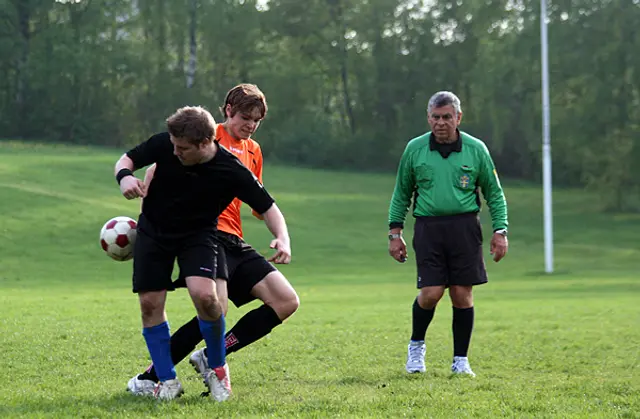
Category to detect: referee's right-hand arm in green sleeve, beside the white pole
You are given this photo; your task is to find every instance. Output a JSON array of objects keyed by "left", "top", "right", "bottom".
[{"left": 478, "top": 147, "right": 509, "bottom": 262}]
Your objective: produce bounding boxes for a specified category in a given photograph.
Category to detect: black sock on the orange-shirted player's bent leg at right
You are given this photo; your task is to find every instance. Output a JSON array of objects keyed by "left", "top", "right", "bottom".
[{"left": 225, "top": 304, "right": 282, "bottom": 354}]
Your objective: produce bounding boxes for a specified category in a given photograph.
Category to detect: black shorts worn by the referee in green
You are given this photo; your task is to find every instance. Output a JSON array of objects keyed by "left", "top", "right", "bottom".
[{"left": 413, "top": 213, "right": 487, "bottom": 288}]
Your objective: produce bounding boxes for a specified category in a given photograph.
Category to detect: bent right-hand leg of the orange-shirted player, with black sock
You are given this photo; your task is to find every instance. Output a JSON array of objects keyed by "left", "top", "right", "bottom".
[{"left": 226, "top": 271, "right": 300, "bottom": 354}]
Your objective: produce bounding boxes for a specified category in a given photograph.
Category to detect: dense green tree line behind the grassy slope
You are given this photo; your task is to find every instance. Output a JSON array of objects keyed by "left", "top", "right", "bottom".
[{"left": 0, "top": 0, "right": 640, "bottom": 210}]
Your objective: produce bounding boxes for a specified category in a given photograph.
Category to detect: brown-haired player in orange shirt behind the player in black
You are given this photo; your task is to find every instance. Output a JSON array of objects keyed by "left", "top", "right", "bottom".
[{"left": 127, "top": 84, "right": 300, "bottom": 395}]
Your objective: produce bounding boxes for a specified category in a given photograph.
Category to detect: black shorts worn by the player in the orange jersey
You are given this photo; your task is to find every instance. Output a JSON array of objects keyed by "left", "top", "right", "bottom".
[{"left": 174, "top": 231, "right": 276, "bottom": 307}]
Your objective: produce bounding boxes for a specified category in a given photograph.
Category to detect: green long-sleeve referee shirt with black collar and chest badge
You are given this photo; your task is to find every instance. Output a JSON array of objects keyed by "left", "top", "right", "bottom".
[{"left": 389, "top": 131, "right": 508, "bottom": 231}]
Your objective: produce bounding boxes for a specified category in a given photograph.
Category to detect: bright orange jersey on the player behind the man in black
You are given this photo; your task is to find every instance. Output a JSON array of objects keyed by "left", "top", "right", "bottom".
[{"left": 216, "top": 124, "right": 262, "bottom": 238}]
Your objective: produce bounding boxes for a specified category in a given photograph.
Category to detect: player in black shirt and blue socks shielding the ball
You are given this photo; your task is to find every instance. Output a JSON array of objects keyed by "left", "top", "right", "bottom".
[{"left": 115, "top": 107, "right": 291, "bottom": 401}]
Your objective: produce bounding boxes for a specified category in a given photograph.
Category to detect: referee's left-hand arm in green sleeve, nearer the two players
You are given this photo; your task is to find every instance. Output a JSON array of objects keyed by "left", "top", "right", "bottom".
[{"left": 389, "top": 146, "right": 415, "bottom": 262}]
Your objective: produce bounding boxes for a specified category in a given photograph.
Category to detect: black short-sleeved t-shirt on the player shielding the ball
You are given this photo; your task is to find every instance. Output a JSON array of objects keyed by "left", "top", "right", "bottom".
[{"left": 127, "top": 132, "right": 274, "bottom": 234}]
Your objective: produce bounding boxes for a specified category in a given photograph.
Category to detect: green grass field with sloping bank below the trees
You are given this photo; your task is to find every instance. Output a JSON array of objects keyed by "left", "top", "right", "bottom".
[{"left": 0, "top": 142, "right": 640, "bottom": 418}]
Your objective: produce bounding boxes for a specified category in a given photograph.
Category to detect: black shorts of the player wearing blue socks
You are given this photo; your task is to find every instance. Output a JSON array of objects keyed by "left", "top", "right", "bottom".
[{"left": 133, "top": 216, "right": 217, "bottom": 293}]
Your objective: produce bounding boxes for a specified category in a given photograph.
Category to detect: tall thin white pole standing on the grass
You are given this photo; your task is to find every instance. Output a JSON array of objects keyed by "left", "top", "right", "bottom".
[{"left": 540, "top": 0, "right": 553, "bottom": 273}]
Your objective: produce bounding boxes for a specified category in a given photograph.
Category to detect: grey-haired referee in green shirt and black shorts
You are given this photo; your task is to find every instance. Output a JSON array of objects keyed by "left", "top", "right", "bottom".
[{"left": 389, "top": 91, "right": 508, "bottom": 376}]
